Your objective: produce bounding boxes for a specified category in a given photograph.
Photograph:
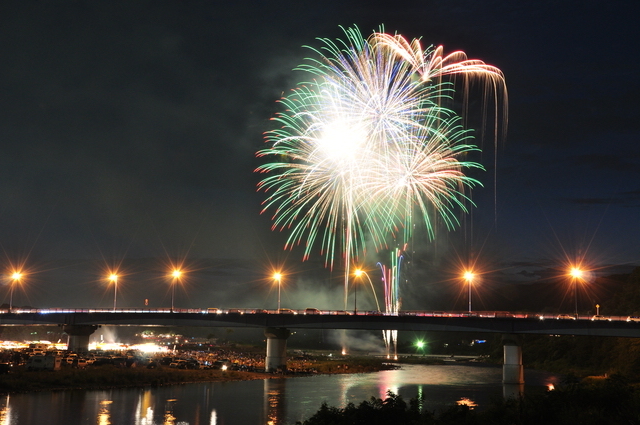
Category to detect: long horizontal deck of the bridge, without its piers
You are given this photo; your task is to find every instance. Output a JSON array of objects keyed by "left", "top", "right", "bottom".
[{"left": 0, "top": 309, "right": 640, "bottom": 338}]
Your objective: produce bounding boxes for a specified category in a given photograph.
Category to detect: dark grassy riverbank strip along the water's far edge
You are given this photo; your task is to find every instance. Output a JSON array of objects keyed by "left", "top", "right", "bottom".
[{"left": 0, "top": 357, "right": 397, "bottom": 394}]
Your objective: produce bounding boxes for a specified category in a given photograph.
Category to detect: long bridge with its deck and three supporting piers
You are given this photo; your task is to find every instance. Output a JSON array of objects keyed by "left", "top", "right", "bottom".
[{"left": 0, "top": 309, "right": 640, "bottom": 385}]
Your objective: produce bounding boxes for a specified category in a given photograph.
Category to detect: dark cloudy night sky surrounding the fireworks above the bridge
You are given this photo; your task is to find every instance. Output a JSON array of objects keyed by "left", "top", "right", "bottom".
[{"left": 0, "top": 0, "right": 640, "bottom": 309}]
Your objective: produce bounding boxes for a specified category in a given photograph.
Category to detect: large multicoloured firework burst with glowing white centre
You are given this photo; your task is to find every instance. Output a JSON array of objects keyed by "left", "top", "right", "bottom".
[{"left": 256, "top": 24, "right": 503, "bottom": 303}]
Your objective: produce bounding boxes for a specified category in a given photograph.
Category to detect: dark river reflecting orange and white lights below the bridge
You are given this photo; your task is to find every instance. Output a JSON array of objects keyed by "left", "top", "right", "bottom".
[{"left": 0, "top": 363, "right": 558, "bottom": 425}]
